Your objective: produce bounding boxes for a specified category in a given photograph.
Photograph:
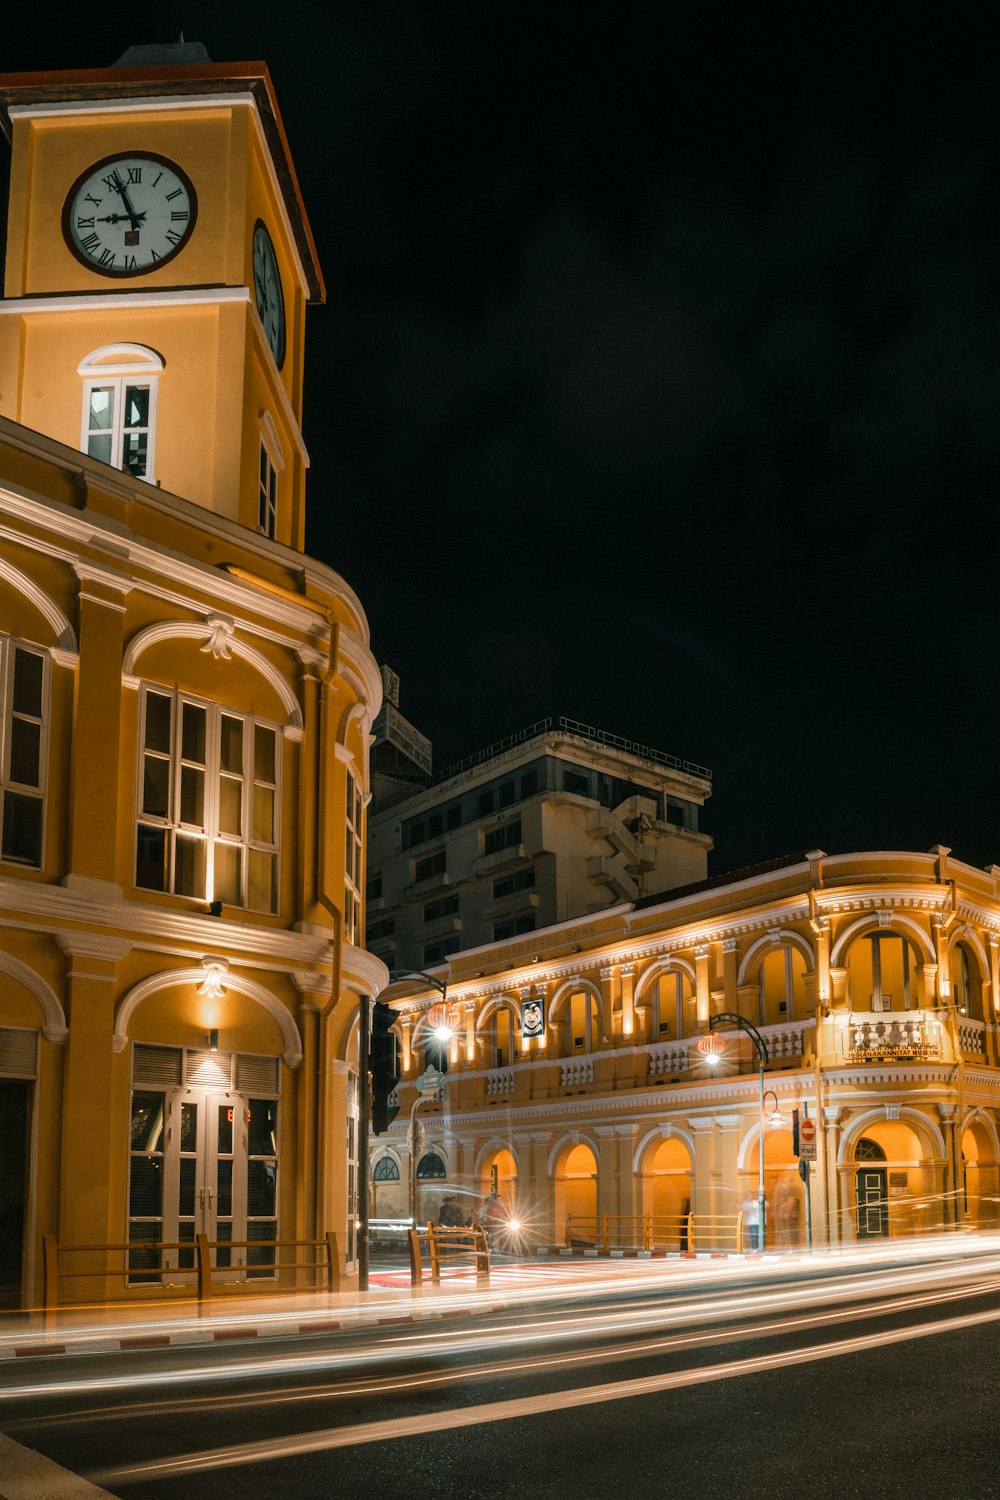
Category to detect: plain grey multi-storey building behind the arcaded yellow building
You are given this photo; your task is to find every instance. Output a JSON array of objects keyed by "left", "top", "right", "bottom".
[{"left": 367, "top": 708, "right": 712, "bottom": 971}]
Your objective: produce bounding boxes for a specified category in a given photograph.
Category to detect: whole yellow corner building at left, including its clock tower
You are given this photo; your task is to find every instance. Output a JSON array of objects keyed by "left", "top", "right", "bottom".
[{"left": 0, "top": 45, "right": 384, "bottom": 1305}]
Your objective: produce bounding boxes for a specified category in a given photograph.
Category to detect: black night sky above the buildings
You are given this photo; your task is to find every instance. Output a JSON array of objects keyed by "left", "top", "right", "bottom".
[{"left": 3, "top": 11, "right": 1000, "bottom": 872}]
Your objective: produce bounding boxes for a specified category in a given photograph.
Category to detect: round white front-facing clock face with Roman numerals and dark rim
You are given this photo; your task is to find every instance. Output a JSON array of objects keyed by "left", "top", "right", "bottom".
[{"left": 63, "top": 152, "right": 198, "bottom": 276}]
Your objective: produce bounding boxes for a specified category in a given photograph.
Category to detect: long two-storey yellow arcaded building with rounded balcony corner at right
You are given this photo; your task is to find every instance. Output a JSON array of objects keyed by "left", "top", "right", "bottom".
[{"left": 370, "top": 848, "right": 1000, "bottom": 1253}]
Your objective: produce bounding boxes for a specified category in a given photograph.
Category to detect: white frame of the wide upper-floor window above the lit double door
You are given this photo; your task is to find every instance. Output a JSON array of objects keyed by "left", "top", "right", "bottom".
[{"left": 133, "top": 683, "right": 283, "bottom": 917}]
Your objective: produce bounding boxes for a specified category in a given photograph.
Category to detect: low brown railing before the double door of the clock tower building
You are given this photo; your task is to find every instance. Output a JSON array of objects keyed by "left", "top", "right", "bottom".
[{"left": 42, "top": 1233, "right": 340, "bottom": 1313}]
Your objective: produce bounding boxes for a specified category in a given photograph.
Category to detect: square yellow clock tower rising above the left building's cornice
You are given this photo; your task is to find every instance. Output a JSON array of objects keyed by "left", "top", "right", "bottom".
[{"left": 0, "top": 42, "right": 325, "bottom": 549}]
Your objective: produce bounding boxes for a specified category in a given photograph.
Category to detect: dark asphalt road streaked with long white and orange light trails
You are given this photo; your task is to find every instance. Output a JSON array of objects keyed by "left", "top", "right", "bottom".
[{"left": 0, "top": 1245, "right": 1000, "bottom": 1500}]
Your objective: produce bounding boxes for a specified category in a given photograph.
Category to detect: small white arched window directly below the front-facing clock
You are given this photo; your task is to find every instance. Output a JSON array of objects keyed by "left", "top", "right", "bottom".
[{"left": 76, "top": 344, "right": 163, "bottom": 480}]
